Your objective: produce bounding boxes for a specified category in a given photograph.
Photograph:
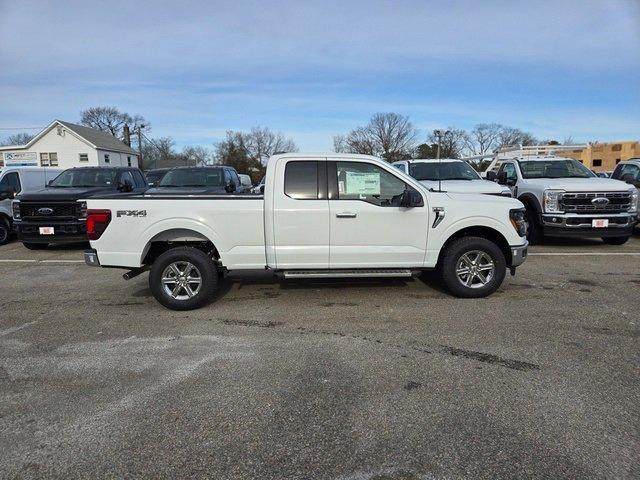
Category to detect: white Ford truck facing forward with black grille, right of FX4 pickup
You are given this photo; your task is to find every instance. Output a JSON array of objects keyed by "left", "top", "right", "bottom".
[{"left": 487, "top": 157, "right": 638, "bottom": 245}]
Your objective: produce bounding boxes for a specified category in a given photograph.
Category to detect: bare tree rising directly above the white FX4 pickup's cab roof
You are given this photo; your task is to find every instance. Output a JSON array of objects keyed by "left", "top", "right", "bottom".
[{"left": 333, "top": 113, "right": 418, "bottom": 161}]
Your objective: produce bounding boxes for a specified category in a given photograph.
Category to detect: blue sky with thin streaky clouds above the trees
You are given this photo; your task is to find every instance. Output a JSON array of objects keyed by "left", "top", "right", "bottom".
[{"left": 0, "top": 0, "right": 640, "bottom": 151}]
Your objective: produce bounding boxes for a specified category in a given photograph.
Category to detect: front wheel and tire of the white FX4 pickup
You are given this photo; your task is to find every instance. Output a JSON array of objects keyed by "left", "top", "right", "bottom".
[{"left": 440, "top": 237, "right": 507, "bottom": 298}]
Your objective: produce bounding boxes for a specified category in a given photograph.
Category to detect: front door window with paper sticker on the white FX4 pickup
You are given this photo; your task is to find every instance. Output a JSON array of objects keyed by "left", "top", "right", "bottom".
[{"left": 336, "top": 162, "right": 410, "bottom": 207}]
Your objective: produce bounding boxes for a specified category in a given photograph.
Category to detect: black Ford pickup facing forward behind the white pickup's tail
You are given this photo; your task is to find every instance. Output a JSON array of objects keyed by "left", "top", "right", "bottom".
[{"left": 13, "top": 167, "right": 149, "bottom": 250}]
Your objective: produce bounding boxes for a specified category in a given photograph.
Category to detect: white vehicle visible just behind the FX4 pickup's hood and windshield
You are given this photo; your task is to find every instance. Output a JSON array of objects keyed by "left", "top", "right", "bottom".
[{"left": 392, "top": 158, "right": 511, "bottom": 197}]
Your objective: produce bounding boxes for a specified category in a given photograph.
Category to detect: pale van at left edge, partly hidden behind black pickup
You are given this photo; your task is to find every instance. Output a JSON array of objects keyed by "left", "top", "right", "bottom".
[{"left": 0, "top": 167, "right": 62, "bottom": 245}]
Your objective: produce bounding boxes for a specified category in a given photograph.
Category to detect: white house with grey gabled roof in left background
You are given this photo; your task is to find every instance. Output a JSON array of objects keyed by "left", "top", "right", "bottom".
[{"left": 0, "top": 120, "right": 138, "bottom": 168}]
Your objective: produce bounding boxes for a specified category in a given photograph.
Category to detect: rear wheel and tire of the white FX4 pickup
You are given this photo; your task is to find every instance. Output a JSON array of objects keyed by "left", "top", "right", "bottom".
[{"left": 149, "top": 247, "right": 219, "bottom": 310}]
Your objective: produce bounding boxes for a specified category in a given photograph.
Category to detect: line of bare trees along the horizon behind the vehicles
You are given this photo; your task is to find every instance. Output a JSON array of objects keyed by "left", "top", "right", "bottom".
[{"left": 1, "top": 106, "right": 573, "bottom": 176}]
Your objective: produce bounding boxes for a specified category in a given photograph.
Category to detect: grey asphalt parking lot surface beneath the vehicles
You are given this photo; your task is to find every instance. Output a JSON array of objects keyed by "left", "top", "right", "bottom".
[{"left": 0, "top": 237, "right": 640, "bottom": 480}]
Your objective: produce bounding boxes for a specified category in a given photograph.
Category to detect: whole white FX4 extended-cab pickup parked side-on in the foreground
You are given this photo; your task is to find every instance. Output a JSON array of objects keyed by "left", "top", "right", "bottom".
[{"left": 85, "top": 154, "right": 528, "bottom": 310}]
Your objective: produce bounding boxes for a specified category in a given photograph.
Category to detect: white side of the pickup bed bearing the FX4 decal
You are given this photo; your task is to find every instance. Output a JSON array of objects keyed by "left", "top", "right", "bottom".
[{"left": 86, "top": 194, "right": 266, "bottom": 269}]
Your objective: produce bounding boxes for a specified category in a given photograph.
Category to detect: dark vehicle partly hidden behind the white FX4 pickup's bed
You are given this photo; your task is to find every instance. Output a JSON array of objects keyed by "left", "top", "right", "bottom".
[{"left": 147, "top": 166, "right": 245, "bottom": 195}]
